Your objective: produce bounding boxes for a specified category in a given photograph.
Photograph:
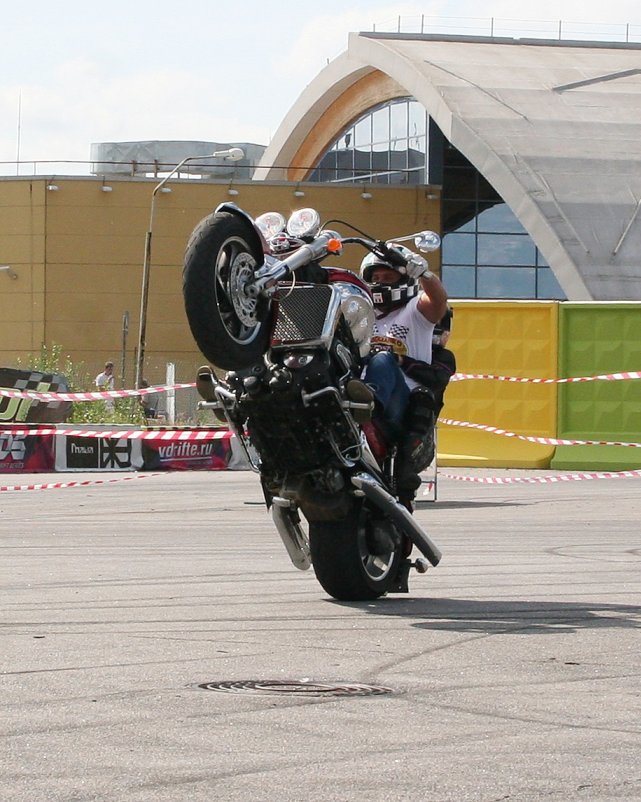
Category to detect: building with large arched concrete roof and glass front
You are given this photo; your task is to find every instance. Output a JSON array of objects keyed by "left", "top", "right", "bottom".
[{"left": 254, "top": 33, "right": 641, "bottom": 301}]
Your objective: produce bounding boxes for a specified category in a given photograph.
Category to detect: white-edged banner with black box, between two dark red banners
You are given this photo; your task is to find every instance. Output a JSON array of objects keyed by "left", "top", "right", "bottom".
[{"left": 55, "top": 434, "right": 143, "bottom": 471}]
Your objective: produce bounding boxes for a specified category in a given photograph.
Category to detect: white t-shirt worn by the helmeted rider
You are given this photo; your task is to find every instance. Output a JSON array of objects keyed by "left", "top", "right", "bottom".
[{"left": 371, "top": 294, "right": 434, "bottom": 390}]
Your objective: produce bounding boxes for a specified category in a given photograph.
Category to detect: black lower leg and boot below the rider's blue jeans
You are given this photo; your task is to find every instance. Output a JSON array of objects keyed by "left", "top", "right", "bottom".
[{"left": 396, "top": 387, "right": 436, "bottom": 497}]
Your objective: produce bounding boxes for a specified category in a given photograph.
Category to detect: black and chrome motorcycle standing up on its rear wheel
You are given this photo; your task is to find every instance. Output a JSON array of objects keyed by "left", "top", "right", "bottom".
[{"left": 183, "top": 203, "right": 441, "bottom": 601}]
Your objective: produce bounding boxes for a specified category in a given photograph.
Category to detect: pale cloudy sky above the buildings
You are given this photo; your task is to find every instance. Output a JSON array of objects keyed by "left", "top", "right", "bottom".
[{"left": 0, "top": 0, "right": 641, "bottom": 175}]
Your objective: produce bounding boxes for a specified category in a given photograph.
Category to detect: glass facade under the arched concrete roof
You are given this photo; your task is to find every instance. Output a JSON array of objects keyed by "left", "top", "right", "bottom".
[{"left": 308, "top": 98, "right": 566, "bottom": 300}]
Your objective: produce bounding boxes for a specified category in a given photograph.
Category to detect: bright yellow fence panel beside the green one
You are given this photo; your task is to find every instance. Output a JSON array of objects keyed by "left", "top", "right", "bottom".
[{"left": 438, "top": 301, "right": 558, "bottom": 468}]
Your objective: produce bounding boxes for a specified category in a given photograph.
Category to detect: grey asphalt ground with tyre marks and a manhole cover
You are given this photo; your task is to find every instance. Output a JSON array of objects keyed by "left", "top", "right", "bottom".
[{"left": 0, "top": 469, "right": 641, "bottom": 802}]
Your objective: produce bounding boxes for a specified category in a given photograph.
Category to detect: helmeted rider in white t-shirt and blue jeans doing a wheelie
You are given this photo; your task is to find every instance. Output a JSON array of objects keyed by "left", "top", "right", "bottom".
[{"left": 350, "top": 245, "right": 448, "bottom": 498}]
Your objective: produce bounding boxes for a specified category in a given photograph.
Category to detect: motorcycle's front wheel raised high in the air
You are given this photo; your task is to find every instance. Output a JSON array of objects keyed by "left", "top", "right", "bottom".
[{"left": 183, "top": 212, "right": 269, "bottom": 370}]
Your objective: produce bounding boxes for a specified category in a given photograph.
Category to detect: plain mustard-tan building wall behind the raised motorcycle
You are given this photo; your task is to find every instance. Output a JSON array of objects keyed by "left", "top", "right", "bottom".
[{"left": 0, "top": 177, "right": 439, "bottom": 386}]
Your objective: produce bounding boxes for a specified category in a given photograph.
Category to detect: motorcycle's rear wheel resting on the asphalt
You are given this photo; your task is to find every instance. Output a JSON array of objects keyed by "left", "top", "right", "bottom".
[{"left": 309, "top": 500, "right": 403, "bottom": 601}]
